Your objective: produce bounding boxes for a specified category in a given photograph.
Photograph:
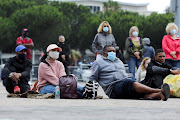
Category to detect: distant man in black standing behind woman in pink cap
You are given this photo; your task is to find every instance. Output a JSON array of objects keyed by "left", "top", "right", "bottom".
[{"left": 57, "top": 35, "right": 70, "bottom": 74}]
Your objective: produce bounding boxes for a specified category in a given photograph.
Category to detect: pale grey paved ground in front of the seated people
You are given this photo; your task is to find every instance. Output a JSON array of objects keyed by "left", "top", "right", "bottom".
[{"left": 0, "top": 82, "right": 180, "bottom": 120}]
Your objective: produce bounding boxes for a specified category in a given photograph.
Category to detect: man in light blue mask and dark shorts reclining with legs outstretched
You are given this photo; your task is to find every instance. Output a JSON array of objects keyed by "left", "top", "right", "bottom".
[{"left": 90, "top": 45, "right": 170, "bottom": 101}]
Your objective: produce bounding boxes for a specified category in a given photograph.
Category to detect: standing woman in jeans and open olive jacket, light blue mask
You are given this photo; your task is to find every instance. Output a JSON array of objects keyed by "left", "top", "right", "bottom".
[{"left": 125, "top": 26, "right": 145, "bottom": 80}]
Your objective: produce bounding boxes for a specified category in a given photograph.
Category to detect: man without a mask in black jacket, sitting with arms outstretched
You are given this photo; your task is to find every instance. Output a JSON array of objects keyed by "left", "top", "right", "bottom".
[{"left": 142, "top": 49, "right": 180, "bottom": 88}]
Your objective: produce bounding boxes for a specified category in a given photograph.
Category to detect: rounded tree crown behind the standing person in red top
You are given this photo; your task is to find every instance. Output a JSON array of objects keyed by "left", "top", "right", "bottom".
[{"left": 10, "top": 5, "right": 68, "bottom": 48}]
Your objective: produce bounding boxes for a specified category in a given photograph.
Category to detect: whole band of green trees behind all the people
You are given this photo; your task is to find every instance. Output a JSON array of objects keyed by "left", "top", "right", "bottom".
[{"left": 0, "top": 0, "right": 174, "bottom": 52}]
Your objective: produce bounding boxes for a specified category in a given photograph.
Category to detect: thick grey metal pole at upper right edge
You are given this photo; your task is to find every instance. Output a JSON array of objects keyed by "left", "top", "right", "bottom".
[{"left": 174, "top": 0, "right": 180, "bottom": 36}]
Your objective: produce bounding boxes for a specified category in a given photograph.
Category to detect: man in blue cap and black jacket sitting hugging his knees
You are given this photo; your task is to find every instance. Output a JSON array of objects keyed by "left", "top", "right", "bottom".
[{"left": 3, "top": 45, "right": 32, "bottom": 94}]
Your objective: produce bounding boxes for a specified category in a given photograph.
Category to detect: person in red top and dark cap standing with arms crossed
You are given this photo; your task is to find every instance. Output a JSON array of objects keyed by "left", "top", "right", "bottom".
[{"left": 16, "top": 28, "right": 34, "bottom": 60}]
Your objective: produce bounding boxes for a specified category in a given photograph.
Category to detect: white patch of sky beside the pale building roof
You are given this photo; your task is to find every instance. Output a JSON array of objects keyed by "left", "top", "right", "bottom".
[{"left": 114, "top": 0, "right": 170, "bottom": 13}]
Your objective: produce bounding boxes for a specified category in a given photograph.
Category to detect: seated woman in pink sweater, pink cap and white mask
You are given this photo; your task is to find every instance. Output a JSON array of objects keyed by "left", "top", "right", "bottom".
[{"left": 37, "top": 44, "right": 84, "bottom": 95}]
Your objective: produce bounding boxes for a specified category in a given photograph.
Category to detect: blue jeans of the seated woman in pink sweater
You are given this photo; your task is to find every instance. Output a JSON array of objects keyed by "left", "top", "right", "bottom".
[{"left": 40, "top": 84, "right": 84, "bottom": 96}]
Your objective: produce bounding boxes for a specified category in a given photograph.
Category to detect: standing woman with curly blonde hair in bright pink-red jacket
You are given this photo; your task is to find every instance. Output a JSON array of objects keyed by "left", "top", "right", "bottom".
[{"left": 162, "top": 23, "right": 180, "bottom": 68}]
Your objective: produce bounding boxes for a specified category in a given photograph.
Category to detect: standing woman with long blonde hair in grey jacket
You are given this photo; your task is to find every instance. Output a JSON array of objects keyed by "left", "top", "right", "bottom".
[{"left": 92, "top": 21, "right": 116, "bottom": 60}]
